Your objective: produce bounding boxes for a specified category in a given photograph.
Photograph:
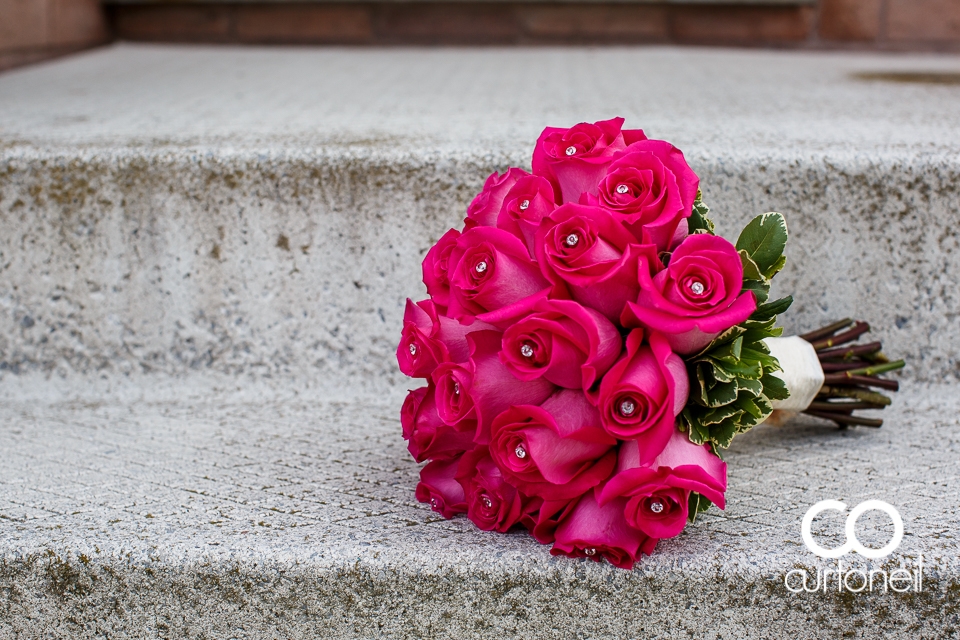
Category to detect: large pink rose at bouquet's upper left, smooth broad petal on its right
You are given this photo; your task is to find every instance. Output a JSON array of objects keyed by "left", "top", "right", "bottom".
[{"left": 449, "top": 227, "right": 550, "bottom": 321}]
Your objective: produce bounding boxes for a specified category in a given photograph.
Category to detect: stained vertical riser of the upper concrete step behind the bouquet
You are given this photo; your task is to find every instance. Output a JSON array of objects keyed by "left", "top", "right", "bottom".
[{"left": 0, "top": 148, "right": 960, "bottom": 389}]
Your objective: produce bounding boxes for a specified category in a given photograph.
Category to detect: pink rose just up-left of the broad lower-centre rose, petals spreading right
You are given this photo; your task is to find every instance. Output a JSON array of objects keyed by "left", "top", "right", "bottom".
[{"left": 433, "top": 331, "right": 556, "bottom": 444}]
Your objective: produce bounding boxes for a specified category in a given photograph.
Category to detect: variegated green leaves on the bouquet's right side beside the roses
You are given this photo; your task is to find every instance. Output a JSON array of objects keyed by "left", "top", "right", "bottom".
[{"left": 680, "top": 213, "right": 793, "bottom": 456}]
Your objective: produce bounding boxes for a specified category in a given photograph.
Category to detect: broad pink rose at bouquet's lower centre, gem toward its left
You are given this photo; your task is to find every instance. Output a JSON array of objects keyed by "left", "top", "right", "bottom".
[{"left": 490, "top": 389, "right": 617, "bottom": 500}]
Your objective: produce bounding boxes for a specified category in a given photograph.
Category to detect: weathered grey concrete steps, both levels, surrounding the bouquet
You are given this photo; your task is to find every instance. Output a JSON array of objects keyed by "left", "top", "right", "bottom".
[{"left": 0, "top": 45, "right": 960, "bottom": 639}]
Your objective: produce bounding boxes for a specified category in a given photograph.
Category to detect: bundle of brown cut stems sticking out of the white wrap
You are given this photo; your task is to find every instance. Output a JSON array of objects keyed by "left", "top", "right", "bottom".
[{"left": 800, "top": 318, "right": 904, "bottom": 429}]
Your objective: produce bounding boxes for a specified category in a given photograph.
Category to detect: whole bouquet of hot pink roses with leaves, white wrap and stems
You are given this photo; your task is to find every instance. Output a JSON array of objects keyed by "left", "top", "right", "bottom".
[{"left": 397, "top": 118, "right": 902, "bottom": 568}]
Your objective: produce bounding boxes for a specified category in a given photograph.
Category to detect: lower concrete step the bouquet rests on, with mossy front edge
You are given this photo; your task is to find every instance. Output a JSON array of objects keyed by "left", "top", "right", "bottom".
[{"left": 0, "top": 376, "right": 960, "bottom": 640}]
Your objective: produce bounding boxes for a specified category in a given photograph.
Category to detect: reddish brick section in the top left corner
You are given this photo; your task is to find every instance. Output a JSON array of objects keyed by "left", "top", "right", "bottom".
[{"left": 0, "top": 0, "right": 110, "bottom": 69}]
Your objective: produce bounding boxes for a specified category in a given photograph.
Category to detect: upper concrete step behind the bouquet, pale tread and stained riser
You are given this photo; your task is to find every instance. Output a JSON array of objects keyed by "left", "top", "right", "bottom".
[{"left": 0, "top": 46, "right": 960, "bottom": 387}]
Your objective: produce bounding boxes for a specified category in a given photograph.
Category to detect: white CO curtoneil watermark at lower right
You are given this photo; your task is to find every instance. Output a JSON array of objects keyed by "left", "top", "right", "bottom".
[{"left": 783, "top": 500, "right": 923, "bottom": 593}]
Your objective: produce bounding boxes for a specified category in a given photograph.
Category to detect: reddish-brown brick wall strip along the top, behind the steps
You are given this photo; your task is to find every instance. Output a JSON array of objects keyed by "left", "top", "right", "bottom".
[{"left": 0, "top": 0, "right": 960, "bottom": 69}]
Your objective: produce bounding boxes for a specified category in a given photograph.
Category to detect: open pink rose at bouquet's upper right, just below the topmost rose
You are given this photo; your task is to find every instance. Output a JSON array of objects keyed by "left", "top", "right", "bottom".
[{"left": 586, "top": 140, "right": 700, "bottom": 251}]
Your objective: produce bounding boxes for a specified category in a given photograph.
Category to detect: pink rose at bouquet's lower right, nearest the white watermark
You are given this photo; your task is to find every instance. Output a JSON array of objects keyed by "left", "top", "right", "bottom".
[{"left": 600, "top": 430, "right": 727, "bottom": 538}]
